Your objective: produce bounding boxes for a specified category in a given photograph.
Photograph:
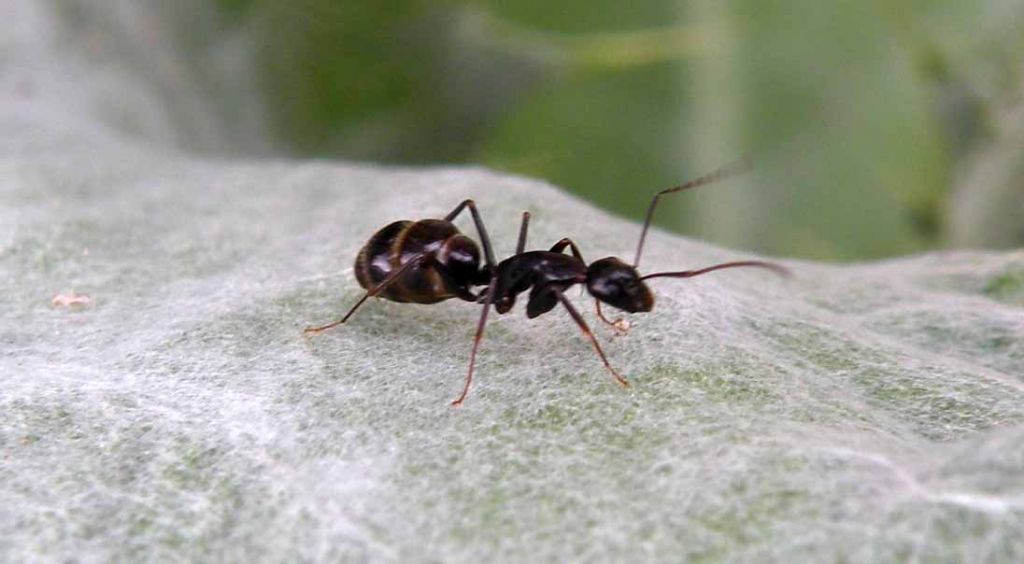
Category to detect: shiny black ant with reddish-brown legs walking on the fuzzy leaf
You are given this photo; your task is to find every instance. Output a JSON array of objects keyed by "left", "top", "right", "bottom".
[{"left": 303, "top": 159, "right": 788, "bottom": 406}]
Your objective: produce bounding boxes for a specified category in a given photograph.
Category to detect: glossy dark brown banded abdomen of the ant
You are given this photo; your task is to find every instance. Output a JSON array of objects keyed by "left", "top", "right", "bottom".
[{"left": 355, "top": 219, "right": 459, "bottom": 304}]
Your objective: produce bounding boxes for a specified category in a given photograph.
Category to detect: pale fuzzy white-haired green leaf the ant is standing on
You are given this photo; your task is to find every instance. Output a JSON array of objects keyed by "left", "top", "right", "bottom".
[{"left": 0, "top": 2, "right": 1024, "bottom": 562}]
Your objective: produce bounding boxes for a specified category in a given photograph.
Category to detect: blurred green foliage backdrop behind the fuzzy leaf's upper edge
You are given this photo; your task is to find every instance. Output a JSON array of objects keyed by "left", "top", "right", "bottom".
[{"left": 214, "top": 0, "right": 1024, "bottom": 260}]
